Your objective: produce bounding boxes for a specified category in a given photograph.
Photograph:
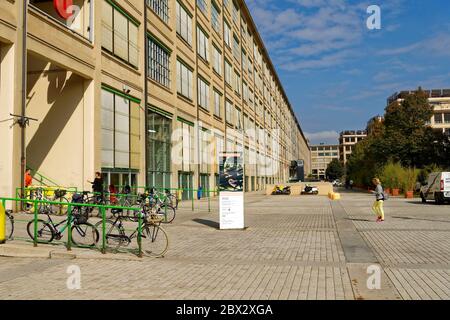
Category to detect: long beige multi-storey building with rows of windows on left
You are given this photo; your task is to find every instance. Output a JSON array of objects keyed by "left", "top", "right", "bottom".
[{"left": 0, "top": 0, "right": 310, "bottom": 197}]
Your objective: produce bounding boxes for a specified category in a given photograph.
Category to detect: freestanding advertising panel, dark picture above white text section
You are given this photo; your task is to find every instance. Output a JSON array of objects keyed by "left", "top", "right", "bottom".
[{"left": 219, "top": 152, "right": 244, "bottom": 230}]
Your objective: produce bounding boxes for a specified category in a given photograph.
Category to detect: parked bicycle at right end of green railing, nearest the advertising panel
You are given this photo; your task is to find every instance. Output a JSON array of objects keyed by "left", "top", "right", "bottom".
[{"left": 95, "top": 205, "right": 169, "bottom": 257}]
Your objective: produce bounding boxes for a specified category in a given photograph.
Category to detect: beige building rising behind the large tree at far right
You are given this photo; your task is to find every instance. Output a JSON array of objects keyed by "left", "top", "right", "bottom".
[{"left": 387, "top": 89, "right": 450, "bottom": 136}]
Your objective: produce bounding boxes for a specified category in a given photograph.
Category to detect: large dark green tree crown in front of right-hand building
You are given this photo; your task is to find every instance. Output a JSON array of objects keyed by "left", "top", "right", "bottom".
[{"left": 347, "top": 88, "right": 450, "bottom": 186}]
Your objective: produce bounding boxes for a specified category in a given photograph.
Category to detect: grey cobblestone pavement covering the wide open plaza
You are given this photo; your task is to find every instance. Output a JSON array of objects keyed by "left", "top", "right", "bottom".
[{"left": 0, "top": 192, "right": 450, "bottom": 300}]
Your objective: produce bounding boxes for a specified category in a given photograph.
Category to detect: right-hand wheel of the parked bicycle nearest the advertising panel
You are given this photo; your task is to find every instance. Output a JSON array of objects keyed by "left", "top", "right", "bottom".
[{"left": 141, "top": 224, "right": 169, "bottom": 258}]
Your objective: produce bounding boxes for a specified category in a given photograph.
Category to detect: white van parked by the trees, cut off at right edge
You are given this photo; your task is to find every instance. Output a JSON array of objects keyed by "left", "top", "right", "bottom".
[{"left": 420, "top": 172, "right": 450, "bottom": 204}]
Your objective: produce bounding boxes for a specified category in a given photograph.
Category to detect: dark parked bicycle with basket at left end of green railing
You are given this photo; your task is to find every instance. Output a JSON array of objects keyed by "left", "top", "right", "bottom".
[{"left": 27, "top": 194, "right": 99, "bottom": 247}]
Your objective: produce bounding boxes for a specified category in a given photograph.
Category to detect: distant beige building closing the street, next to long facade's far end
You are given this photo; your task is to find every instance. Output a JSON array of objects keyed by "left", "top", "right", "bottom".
[{"left": 311, "top": 144, "right": 339, "bottom": 180}]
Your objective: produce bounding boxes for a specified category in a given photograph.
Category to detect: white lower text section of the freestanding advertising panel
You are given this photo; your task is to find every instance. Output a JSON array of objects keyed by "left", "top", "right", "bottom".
[{"left": 220, "top": 192, "right": 244, "bottom": 230}]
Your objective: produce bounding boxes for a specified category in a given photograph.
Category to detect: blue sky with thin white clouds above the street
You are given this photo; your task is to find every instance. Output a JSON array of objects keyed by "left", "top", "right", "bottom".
[{"left": 246, "top": 0, "right": 450, "bottom": 144}]
